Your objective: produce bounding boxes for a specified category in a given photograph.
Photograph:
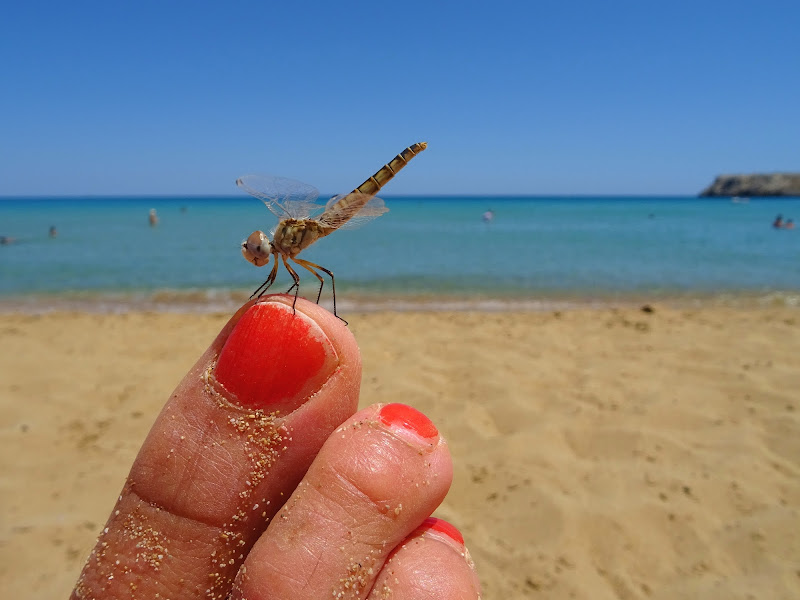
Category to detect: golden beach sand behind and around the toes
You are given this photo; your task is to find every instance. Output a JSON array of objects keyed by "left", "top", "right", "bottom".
[{"left": 0, "top": 305, "right": 800, "bottom": 599}]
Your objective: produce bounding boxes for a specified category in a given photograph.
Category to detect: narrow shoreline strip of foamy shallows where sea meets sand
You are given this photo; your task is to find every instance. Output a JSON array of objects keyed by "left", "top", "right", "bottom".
[{"left": 0, "top": 288, "right": 800, "bottom": 315}]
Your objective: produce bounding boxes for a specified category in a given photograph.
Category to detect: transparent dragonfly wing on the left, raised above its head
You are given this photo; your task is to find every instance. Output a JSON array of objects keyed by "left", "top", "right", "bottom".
[{"left": 236, "top": 175, "right": 322, "bottom": 219}]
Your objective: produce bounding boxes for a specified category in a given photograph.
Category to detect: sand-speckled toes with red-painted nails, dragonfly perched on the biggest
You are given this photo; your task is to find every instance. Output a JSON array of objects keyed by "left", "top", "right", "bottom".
[{"left": 72, "top": 294, "right": 480, "bottom": 600}]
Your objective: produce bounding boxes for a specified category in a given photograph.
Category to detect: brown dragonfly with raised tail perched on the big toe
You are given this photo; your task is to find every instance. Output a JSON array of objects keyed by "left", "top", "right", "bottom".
[{"left": 236, "top": 142, "right": 428, "bottom": 323}]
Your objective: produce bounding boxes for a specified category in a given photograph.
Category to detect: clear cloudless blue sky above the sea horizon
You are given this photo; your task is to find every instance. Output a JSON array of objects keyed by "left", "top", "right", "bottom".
[{"left": 0, "top": 0, "right": 800, "bottom": 195}]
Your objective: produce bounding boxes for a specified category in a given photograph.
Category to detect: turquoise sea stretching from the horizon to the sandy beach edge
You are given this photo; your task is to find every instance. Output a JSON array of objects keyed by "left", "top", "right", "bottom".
[{"left": 0, "top": 196, "right": 800, "bottom": 312}]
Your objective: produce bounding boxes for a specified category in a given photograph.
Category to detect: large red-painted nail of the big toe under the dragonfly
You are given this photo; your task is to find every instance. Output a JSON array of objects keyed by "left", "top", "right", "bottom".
[{"left": 214, "top": 302, "right": 339, "bottom": 413}]
